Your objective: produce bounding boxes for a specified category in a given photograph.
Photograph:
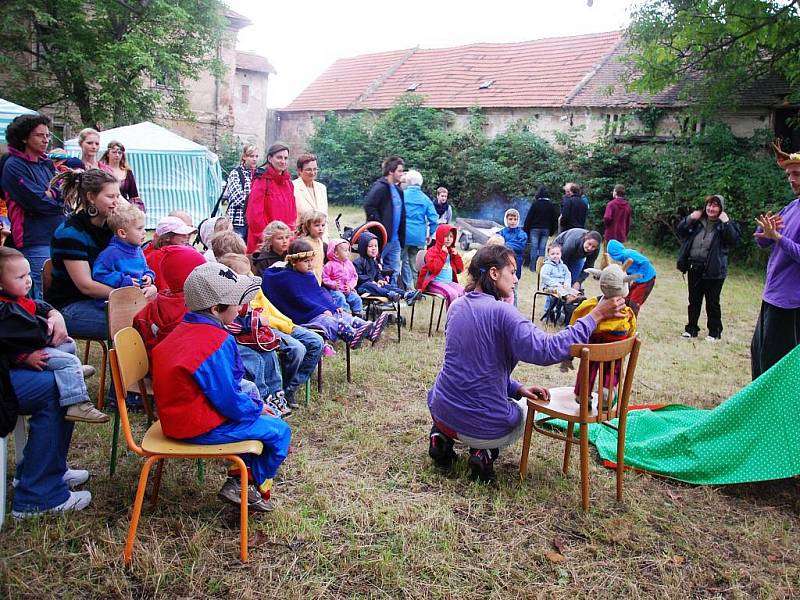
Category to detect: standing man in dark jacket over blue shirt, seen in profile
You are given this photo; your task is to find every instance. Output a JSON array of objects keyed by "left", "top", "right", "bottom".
[{"left": 364, "top": 156, "right": 406, "bottom": 285}]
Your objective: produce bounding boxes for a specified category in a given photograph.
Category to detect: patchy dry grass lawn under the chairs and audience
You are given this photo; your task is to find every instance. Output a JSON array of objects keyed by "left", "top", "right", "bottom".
[{"left": 0, "top": 207, "right": 800, "bottom": 599}]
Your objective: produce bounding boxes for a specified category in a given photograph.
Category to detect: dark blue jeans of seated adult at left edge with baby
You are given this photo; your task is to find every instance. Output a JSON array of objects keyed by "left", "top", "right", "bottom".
[{"left": 9, "top": 369, "right": 73, "bottom": 512}]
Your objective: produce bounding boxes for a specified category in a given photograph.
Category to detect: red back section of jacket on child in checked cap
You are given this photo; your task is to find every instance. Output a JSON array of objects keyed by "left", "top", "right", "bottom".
[{"left": 152, "top": 321, "right": 228, "bottom": 439}]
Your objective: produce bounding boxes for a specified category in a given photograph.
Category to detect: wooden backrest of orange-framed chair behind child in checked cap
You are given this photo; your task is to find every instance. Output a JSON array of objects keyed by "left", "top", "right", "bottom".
[{"left": 108, "top": 327, "right": 150, "bottom": 455}]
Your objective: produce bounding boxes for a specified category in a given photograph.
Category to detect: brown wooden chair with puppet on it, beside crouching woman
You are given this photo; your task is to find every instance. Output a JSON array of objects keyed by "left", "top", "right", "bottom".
[{"left": 519, "top": 336, "right": 642, "bottom": 510}]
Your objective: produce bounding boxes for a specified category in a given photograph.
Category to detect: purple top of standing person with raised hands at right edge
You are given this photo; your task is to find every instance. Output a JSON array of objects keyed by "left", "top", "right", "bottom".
[{"left": 756, "top": 198, "right": 800, "bottom": 308}]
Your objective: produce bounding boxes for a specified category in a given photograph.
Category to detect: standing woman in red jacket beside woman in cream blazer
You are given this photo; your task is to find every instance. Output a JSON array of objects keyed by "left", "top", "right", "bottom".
[{"left": 247, "top": 144, "right": 297, "bottom": 254}]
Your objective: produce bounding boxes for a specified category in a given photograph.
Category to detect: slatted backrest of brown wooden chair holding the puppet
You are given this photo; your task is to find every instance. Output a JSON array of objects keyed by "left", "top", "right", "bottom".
[{"left": 570, "top": 335, "right": 642, "bottom": 421}]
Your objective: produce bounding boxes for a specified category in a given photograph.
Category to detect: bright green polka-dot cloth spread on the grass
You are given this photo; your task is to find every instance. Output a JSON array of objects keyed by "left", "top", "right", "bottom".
[{"left": 544, "top": 346, "right": 800, "bottom": 484}]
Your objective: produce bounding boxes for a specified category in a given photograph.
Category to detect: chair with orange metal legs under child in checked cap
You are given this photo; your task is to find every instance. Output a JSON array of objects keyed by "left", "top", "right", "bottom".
[{"left": 110, "top": 327, "right": 263, "bottom": 564}]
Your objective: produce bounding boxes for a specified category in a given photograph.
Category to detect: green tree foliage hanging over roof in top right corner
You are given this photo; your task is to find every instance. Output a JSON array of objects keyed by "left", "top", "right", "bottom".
[{"left": 628, "top": 0, "right": 800, "bottom": 113}]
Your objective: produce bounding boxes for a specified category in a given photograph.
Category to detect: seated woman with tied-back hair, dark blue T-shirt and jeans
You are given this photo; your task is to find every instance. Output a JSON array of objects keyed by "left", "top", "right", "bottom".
[{"left": 47, "top": 169, "right": 156, "bottom": 339}]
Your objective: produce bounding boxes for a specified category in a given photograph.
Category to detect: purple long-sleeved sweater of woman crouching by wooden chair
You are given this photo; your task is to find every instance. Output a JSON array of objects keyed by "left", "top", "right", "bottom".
[{"left": 428, "top": 292, "right": 597, "bottom": 440}]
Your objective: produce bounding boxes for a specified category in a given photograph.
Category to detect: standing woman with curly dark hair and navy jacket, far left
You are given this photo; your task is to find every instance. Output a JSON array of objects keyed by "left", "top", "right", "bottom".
[{"left": 2, "top": 114, "right": 64, "bottom": 299}]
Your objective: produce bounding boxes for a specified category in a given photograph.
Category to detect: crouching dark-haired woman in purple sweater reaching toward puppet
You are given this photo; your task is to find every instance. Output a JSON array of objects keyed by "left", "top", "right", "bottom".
[{"left": 428, "top": 245, "right": 625, "bottom": 482}]
